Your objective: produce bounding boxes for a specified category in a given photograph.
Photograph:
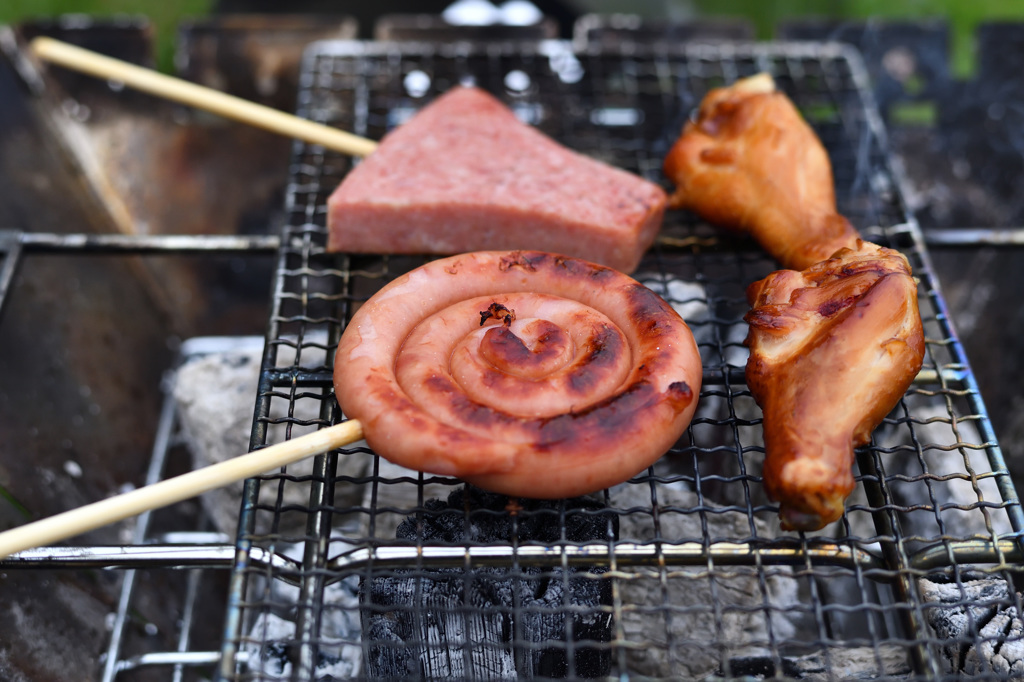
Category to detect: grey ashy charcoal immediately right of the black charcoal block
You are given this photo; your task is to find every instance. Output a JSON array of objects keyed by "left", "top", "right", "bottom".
[{"left": 611, "top": 484, "right": 798, "bottom": 679}]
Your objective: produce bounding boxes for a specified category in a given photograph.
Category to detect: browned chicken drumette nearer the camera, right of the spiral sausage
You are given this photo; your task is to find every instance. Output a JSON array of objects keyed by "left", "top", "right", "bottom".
[{"left": 744, "top": 240, "right": 925, "bottom": 530}]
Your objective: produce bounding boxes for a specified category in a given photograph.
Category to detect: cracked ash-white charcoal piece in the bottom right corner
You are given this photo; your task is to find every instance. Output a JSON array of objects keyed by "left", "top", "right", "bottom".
[{"left": 918, "top": 577, "right": 1024, "bottom": 679}]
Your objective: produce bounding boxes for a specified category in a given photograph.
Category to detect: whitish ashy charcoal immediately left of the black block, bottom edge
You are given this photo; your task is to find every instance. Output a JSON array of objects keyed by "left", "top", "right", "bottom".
[{"left": 244, "top": 538, "right": 362, "bottom": 680}]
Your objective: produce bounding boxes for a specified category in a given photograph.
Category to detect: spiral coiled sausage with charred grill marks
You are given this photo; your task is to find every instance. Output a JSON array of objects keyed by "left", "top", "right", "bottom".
[{"left": 334, "top": 251, "right": 701, "bottom": 499}]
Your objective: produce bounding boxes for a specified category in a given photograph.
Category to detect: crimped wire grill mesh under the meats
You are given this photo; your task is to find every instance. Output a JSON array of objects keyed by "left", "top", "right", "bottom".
[{"left": 221, "top": 41, "right": 1024, "bottom": 680}]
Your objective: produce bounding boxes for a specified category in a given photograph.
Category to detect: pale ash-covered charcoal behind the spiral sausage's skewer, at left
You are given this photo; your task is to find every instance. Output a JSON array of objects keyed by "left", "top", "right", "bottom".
[{"left": 173, "top": 343, "right": 369, "bottom": 536}]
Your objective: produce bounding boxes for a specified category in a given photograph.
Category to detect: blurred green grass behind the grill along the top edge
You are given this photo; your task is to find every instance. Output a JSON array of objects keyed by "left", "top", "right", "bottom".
[{"left": 0, "top": 0, "right": 1024, "bottom": 77}]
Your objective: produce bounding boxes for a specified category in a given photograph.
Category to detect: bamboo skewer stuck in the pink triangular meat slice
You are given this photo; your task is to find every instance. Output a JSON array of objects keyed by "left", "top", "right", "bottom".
[{"left": 30, "top": 37, "right": 377, "bottom": 157}]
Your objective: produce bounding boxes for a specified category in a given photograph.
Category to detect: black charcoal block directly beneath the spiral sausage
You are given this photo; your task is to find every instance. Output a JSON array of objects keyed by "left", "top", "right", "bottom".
[{"left": 360, "top": 486, "right": 617, "bottom": 680}]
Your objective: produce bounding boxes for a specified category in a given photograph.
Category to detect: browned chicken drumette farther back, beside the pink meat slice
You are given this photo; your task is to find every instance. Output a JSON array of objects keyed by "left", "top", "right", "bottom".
[{"left": 665, "top": 74, "right": 857, "bottom": 269}]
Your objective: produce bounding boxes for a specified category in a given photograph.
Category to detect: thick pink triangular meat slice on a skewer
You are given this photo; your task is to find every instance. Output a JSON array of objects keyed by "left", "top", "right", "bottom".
[{"left": 328, "top": 87, "right": 667, "bottom": 272}]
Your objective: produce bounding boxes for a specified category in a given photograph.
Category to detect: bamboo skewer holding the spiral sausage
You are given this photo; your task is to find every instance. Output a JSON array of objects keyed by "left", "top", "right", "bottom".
[{"left": 0, "top": 419, "right": 362, "bottom": 559}]
